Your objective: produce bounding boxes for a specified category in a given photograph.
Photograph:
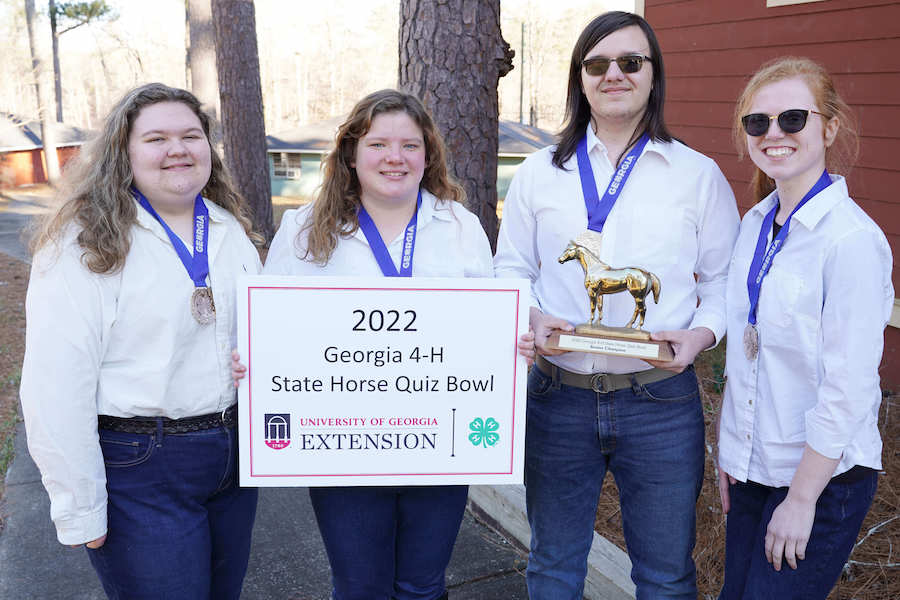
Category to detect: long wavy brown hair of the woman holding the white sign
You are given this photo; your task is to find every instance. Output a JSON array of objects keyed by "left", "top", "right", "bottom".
[{"left": 294, "top": 89, "right": 466, "bottom": 265}]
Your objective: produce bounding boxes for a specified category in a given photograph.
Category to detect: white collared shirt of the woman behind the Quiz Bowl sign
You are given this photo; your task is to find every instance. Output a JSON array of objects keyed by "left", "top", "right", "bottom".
[{"left": 263, "top": 190, "right": 493, "bottom": 277}]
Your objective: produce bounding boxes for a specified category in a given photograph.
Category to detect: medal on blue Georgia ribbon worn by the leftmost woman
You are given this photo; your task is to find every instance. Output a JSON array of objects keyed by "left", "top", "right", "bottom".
[{"left": 131, "top": 187, "right": 216, "bottom": 325}]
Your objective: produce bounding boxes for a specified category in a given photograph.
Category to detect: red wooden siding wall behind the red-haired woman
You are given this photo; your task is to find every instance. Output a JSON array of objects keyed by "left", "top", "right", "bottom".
[{"left": 644, "top": 0, "right": 900, "bottom": 389}]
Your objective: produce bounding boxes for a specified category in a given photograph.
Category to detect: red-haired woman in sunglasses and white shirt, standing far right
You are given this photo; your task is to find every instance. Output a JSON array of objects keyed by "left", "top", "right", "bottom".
[{"left": 719, "top": 58, "right": 894, "bottom": 600}]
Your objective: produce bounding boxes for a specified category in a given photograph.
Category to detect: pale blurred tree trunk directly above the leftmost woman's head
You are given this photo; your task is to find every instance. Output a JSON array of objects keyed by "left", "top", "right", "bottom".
[{"left": 185, "top": 0, "right": 219, "bottom": 119}]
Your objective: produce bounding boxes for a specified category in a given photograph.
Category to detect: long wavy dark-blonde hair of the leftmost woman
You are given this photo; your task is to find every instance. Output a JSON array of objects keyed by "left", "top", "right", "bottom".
[{"left": 31, "top": 83, "right": 261, "bottom": 273}]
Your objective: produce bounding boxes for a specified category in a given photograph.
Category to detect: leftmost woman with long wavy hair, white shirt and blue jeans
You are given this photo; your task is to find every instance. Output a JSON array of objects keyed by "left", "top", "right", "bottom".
[{"left": 21, "top": 83, "right": 261, "bottom": 600}]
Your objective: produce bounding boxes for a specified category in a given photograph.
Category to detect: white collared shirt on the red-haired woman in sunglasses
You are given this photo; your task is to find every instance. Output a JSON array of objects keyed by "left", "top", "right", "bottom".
[{"left": 719, "top": 176, "right": 894, "bottom": 487}]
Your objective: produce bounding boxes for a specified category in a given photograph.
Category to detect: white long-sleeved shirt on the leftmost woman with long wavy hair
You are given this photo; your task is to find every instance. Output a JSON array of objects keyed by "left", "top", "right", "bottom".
[{"left": 20, "top": 201, "right": 261, "bottom": 544}]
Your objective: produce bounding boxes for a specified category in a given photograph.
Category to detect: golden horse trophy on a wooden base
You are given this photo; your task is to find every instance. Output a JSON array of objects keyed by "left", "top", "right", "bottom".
[{"left": 548, "top": 230, "right": 675, "bottom": 360}]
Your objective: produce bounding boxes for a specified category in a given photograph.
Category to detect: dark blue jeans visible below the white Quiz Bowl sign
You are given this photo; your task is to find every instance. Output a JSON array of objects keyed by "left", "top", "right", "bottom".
[{"left": 309, "top": 485, "right": 469, "bottom": 600}]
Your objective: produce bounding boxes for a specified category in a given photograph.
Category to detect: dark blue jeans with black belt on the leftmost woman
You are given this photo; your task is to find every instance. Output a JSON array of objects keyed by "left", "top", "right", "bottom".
[{"left": 87, "top": 420, "right": 257, "bottom": 600}]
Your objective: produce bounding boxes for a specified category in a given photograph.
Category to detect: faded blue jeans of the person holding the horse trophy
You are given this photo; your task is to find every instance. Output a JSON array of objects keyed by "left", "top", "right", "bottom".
[{"left": 525, "top": 368, "right": 704, "bottom": 600}]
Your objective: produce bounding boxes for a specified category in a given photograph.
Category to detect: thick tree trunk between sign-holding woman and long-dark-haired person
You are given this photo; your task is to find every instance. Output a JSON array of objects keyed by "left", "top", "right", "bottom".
[{"left": 399, "top": 0, "right": 513, "bottom": 247}]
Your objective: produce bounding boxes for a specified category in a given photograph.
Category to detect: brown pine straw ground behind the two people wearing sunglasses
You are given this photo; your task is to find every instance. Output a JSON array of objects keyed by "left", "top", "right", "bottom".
[{"left": 594, "top": 347, "right": 900, "bottom": 600}]
